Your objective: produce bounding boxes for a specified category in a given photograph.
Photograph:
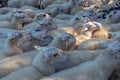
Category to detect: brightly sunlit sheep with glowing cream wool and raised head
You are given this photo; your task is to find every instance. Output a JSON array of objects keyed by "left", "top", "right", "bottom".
[{"left": 74, "top": 22, "right": 108, "bottom": 48}]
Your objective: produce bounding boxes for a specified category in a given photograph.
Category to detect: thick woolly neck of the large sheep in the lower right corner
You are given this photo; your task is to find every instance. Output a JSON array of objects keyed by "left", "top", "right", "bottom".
[{"left": 95, "top": 49, "right": 120, "bottom": 79}]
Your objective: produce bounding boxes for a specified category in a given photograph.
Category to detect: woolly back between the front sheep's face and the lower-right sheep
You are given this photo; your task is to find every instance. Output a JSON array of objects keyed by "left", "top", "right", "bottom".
[{"left": 50, "top": 47, "right": 103, "bottom": 72}]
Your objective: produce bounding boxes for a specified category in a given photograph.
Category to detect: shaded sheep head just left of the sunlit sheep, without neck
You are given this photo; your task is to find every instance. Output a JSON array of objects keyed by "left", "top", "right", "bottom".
[{"left": 54, "top": 33, "right": 76, "bottom": 50}]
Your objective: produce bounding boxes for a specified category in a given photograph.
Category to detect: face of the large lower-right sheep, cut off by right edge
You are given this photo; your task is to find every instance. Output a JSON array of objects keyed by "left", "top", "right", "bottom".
[{"left": 108, "top": 41, "right": 120, "bottom": 59}]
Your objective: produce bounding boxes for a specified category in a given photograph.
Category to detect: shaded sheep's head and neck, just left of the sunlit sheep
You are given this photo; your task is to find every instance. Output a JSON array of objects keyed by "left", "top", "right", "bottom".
[{"left": 48, "top": 32, "right": 76, "bottom": 51}]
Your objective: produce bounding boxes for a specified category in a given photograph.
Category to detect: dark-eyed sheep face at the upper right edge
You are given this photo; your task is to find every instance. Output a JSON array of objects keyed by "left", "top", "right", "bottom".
[{"left": 106, "top": 10, "right": 120, "bottom": 23}]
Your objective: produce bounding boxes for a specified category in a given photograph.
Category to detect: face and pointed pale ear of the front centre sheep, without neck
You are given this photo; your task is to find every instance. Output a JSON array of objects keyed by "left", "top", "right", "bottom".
[{"left": 35, "top": 46, "right": 67, "bottom": 62}]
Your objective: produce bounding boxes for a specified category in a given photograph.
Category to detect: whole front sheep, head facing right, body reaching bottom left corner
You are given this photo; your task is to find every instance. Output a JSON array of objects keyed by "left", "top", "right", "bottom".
[{"left": 1, "top": 47, "right": 67, "bottom": 80}]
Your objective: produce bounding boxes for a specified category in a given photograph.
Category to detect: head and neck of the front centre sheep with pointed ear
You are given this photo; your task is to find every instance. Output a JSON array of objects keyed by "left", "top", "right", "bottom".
[{"left": 32, "top": 46, "right": 67, "bottom": 75}]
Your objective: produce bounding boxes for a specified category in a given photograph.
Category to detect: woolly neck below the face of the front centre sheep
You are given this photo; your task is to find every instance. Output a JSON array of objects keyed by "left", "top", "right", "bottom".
[{"left": 32, "top": 53, "right": 55, "bottom": 76}]
